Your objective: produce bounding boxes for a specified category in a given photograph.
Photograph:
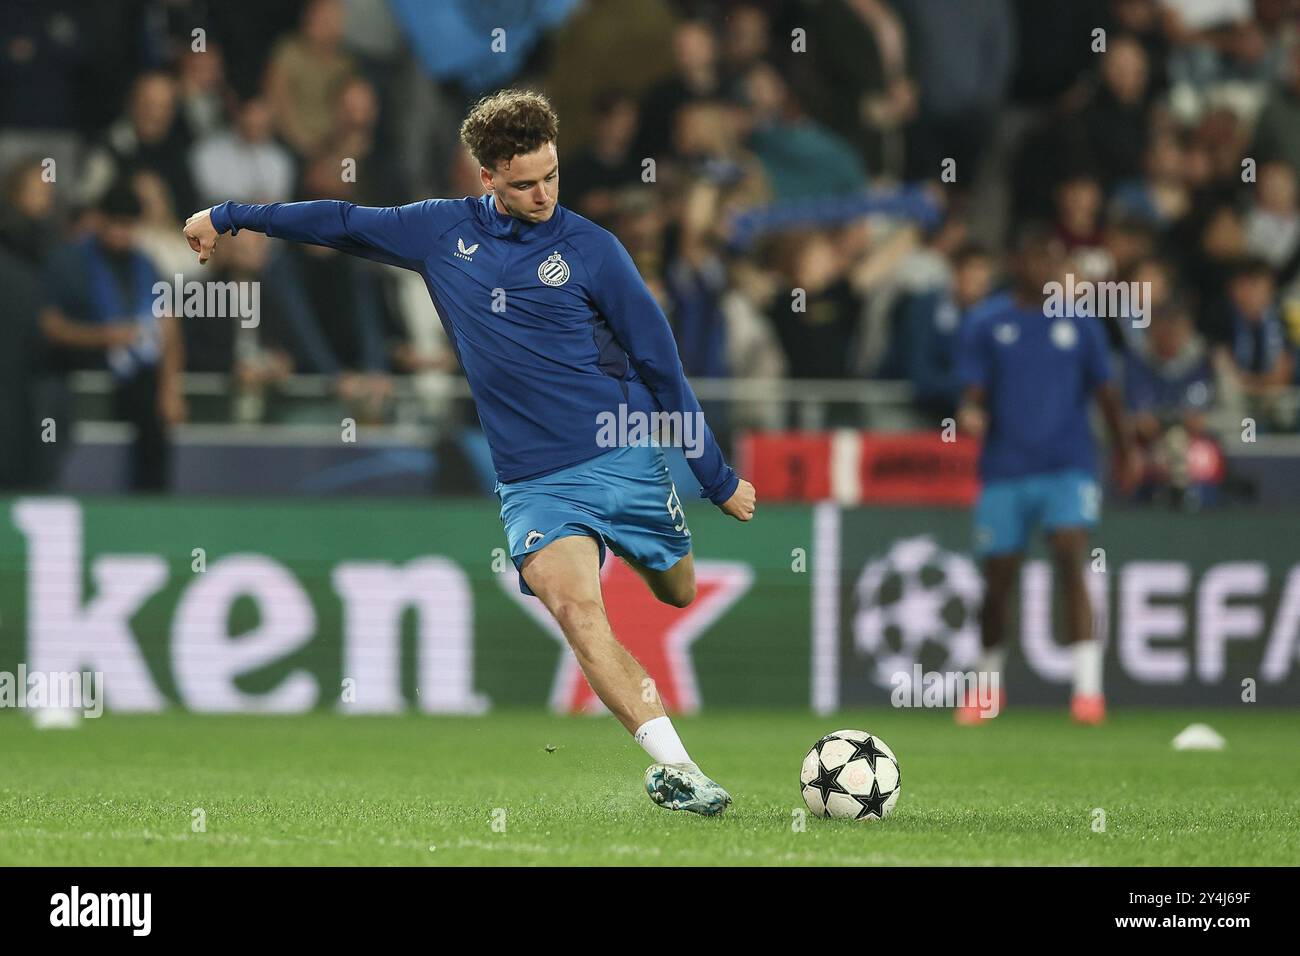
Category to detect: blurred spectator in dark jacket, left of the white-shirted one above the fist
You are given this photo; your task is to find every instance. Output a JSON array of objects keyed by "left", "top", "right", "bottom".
[{"left": 82, "top": 73, "right": 195, "bottom": 215}]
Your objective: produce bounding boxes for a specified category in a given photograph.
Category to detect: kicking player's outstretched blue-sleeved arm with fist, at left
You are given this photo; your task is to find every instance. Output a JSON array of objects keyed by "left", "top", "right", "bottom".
[{"left": 185, "top": 199, "right": 438, "bottom": 269}]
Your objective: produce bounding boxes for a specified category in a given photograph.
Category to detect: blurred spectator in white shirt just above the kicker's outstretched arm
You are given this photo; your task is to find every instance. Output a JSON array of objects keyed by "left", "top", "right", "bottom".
[{"left": 185, "top": 96, "right": 294, "bottom": 205}]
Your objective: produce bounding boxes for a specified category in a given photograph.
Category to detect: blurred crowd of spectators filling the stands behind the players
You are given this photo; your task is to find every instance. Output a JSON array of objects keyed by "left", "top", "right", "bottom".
[{"left": 0, "top": 0, "right": 1300, "bottom": 504}]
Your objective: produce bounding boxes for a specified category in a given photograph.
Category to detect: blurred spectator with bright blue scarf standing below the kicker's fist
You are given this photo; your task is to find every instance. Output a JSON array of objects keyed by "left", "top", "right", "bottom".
[{"left": 40, "top": 182, "right": 186, "bottom": 490}]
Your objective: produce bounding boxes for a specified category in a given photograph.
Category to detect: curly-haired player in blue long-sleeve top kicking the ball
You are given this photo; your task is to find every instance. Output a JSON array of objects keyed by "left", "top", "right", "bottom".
[{"left": 185, "top": 91, "right": 754, "bottom": 816}]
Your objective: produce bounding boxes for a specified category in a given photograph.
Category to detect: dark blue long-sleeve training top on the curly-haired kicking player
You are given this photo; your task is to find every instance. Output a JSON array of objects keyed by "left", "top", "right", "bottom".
[{"left": 212, "top": 195, "right": 738, "bottom": 505}]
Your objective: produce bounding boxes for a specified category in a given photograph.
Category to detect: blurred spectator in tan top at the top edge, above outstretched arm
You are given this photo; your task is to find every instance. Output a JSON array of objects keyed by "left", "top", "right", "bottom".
[{"left": 267, "top": 0, "right": 355, "bottom": 157}]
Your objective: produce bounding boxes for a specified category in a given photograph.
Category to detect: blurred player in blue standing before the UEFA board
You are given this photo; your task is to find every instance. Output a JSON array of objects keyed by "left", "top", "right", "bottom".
[{"left": 956, "top": 226, "right": 1138, "bottom": 724}]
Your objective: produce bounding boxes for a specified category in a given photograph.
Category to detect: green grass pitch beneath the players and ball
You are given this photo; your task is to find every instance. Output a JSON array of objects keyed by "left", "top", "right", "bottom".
[{"left": 0, "top": 708, "right": 1300, "bottom": 866}]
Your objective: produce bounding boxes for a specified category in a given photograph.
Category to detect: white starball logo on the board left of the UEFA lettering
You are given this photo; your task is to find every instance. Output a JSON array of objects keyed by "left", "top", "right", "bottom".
[{"left": 853, "top": 535, "right": 983, "bottom": 688}]
